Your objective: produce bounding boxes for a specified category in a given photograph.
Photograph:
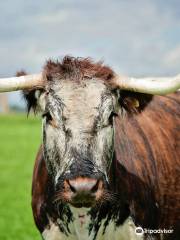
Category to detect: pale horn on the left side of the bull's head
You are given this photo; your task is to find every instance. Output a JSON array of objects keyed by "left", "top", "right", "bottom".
[{"left": 0, "top": 73, "right": 44, "bottom": 92}]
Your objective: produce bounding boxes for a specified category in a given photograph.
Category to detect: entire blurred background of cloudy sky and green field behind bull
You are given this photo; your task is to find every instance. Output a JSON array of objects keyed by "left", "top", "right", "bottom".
[{"left": 0, "top": 0, "right": 180, "bottom": 240}]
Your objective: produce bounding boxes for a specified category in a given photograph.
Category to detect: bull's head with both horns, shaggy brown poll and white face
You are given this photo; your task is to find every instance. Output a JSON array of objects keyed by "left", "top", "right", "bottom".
[{"left": 0, "top": 57, "right": 180, "bottom": 207}]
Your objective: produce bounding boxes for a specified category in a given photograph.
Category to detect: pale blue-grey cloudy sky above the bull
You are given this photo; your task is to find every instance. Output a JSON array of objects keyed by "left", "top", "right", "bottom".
[{"left": 0, "top": 0, "right": 180, "bottom": 107}]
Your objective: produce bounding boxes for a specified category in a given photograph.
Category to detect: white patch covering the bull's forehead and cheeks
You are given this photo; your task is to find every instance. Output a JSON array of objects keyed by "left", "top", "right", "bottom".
[{"left": 43, "top": 79, "right": 117, "bottom": 182}]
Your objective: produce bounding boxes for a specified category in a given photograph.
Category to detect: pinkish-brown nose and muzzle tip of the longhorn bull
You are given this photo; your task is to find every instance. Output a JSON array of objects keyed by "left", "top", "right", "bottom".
[{"left": 65, "top": 177, "right": 103, "bottom": 207}]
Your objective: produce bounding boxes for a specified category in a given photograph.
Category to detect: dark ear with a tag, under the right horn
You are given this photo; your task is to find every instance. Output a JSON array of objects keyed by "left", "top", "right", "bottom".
[{"left": 119, "top": 91, "right": 153, "bottom": 114}]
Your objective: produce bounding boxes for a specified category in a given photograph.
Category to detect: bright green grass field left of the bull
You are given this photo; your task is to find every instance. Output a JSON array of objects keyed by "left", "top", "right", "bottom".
[{"left": 0, "top": 114, "right": 41, "bottom": 240}]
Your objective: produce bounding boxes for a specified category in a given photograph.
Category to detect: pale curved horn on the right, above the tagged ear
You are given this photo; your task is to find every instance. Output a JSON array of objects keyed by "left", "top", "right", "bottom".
[{"left": 113, "top": 74, "right": 180, "bottom": 95}]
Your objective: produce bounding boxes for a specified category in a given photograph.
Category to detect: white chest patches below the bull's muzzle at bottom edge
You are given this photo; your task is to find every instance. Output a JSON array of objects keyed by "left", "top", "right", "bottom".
[{"left": 43, "top": 216, "right": 144, "bottom": 240}]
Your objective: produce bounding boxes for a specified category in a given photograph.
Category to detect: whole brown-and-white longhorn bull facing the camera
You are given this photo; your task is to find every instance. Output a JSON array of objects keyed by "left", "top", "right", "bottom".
[{"left": 0, "top": 57, "right": 180, "bottom": 240}]
